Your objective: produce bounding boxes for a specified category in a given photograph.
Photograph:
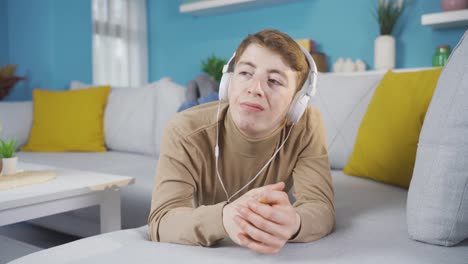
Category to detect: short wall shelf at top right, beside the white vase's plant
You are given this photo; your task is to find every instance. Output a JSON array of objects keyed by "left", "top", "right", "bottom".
[{"left": 421, "top": 9, "right": 468, "bottom": 29}]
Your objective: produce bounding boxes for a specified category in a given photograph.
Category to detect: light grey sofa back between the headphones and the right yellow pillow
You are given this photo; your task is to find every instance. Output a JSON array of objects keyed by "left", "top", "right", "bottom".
[{"left": 310, "top": 72, "right": 384, "bottom": 169}]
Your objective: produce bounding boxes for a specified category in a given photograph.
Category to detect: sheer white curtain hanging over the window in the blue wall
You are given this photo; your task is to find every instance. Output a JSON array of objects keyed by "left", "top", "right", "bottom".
[{"left": 92, "top": 0, "right": 148, "bottom": 87}]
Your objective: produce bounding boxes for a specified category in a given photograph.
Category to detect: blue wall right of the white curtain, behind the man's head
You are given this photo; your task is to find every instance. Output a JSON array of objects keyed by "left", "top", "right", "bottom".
[{"left": 148, "top": 0, "right": 464, "bottom": 84}]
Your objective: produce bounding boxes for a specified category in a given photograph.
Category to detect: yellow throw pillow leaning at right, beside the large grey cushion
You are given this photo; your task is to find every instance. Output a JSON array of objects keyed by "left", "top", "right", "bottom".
[{"left": 343, "top": 68, "right": 441, "bottom": 188}]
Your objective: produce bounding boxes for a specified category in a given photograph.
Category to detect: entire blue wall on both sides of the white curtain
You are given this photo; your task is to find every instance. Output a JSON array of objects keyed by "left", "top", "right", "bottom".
[{"left": 0, "top": 0, "right": 464, "bottom": 100}]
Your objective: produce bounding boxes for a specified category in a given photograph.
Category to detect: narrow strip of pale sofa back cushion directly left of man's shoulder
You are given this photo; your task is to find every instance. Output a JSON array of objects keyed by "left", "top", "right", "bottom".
[{"left": 154, "top": 78, "right": 185, "bottom": 156}]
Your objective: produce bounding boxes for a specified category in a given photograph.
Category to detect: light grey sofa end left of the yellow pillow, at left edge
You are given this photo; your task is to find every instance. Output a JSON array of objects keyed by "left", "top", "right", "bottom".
[{"left": 0, "top": 101, "right": 33, "bottom": 147}]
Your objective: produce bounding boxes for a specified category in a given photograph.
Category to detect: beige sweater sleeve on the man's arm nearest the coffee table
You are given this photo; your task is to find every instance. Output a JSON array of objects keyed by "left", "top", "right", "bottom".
[{"left": 148, "top": 122, "right": 227, "bottom": 246}]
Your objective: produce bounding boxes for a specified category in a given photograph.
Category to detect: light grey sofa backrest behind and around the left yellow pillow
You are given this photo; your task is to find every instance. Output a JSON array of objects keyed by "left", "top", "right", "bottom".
[{"left": 0, "top": 78, "right": 185, "bottom": 156}]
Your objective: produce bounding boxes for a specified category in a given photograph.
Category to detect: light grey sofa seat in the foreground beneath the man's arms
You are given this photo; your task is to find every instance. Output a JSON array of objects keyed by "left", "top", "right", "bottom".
[{"left": 8, "top": 171, "right": 468, "bottom": 264}]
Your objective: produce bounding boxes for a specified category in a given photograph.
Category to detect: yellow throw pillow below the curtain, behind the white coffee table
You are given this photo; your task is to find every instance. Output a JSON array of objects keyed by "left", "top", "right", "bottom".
[{"left": 22, "top": 86, "right": 110, "bottom": 152}]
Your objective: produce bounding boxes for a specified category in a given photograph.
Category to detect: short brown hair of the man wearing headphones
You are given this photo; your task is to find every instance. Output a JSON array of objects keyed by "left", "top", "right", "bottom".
[{"left": 234, "top": 29, "right": 310, "bottom": 91}]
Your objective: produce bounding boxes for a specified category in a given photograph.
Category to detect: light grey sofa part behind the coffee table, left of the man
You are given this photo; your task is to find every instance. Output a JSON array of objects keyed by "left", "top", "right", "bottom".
[{"left": 0, "top": 78, "right": 185, "bottom": 237}]
